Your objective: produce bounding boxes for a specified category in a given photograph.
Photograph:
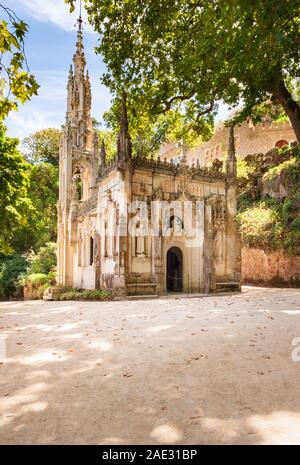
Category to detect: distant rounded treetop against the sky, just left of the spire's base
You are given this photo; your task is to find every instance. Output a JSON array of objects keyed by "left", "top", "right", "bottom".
[{"left": 22, "top": 128, "right": 61, "bottom": 165}]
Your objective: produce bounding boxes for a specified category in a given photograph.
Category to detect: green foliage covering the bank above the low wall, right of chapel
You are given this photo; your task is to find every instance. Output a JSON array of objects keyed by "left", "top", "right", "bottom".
[{"left": 238, "top": 147, "right": 300, "bottom": 255}]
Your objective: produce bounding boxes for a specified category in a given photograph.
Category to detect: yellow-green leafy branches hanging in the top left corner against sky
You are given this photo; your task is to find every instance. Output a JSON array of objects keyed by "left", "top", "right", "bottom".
[{"left": 0, "top": 3, "right": 39, "bottom": 121}]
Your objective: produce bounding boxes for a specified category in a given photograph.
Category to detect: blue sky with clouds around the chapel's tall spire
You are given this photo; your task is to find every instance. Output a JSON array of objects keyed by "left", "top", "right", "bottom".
[{"left": 0, "top": 0, "right": 227, "bottom": 139}]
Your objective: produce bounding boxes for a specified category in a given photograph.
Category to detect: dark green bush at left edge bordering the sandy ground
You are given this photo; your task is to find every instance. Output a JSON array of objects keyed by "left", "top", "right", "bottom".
[{"left": 0, "top": 255, "right": 28, "bottom": 299}]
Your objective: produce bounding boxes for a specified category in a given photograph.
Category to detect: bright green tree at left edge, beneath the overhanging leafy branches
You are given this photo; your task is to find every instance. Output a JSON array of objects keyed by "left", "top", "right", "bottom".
[{"left": 0, "top": 123, "right": 32, "bottom": 254}]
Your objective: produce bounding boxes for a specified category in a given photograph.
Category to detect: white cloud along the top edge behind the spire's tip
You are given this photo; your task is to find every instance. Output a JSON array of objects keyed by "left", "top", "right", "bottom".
[{"left": 8, "top": 0, "right": 94, "bottom": 32}]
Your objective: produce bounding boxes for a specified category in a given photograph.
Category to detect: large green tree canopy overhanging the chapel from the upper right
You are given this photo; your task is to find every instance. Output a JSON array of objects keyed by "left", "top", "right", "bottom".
[{"left": 65, "top": 0, "right": 300, "bottom": 142}]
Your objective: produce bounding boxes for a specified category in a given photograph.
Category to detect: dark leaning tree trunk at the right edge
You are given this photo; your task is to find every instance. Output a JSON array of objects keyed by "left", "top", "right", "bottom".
[{"left": 272, "top": 79, "right": 300, "bottom": 144}]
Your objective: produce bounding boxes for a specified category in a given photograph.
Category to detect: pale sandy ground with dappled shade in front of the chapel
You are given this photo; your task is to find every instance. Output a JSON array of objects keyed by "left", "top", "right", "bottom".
[{"left": 0, "top": 288, "right": 300, "bottom": 444}]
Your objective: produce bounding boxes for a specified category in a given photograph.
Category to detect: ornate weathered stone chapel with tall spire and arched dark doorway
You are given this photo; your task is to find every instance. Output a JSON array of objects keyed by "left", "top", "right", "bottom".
[{"left": 58, "top": 27, "right": 241, "bottom": 295}]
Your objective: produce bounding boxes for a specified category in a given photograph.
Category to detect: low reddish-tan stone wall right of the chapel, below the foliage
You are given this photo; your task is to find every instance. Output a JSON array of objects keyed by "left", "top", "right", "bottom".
[{"left": 242, "top": 247, "right": 300, "bottom": 287}]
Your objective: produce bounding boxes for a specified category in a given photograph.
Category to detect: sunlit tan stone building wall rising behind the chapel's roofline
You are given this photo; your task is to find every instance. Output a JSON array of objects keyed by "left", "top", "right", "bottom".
[{"left": 160, "top": 121, "right": 296, "bottom": 166}]
